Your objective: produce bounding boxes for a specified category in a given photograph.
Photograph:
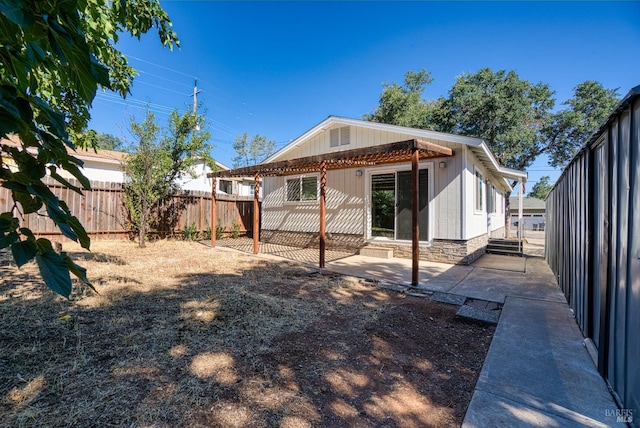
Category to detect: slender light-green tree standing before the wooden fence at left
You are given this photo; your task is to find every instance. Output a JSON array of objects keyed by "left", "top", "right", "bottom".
[{"left": 124, "top": 111, "right": 213, "bottom": 247}]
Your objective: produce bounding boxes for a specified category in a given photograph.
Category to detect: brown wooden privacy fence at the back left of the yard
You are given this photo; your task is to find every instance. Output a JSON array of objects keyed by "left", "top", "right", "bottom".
[{"left": 0, "top": 177, "right": 253, "bottom": 239}]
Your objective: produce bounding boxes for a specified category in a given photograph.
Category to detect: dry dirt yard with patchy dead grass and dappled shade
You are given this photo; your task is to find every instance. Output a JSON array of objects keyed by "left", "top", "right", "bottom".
[{"left": 0, "top": 241, "right": 494, "bottom": 428}]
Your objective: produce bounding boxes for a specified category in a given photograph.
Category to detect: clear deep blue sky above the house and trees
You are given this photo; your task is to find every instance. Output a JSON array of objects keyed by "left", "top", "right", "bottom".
[{"left": 90, "top": 1, "right": 640, "bottom": 195}]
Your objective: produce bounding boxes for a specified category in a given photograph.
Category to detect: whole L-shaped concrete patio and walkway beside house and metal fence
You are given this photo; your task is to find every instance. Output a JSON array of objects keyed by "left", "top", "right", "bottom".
[{"left": 215, "top": 238, "right": 625, "bottom": 428}]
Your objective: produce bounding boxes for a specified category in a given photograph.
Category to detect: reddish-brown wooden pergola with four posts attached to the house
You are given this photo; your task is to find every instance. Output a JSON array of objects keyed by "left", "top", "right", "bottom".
[{"left": 207, "top": 139, "right": 453, "bottom": 285}]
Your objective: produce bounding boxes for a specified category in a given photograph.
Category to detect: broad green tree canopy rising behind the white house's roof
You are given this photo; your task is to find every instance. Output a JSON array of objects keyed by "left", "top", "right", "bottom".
[{"left": 364, "top": 68, "right": 619, "bottom": 170}]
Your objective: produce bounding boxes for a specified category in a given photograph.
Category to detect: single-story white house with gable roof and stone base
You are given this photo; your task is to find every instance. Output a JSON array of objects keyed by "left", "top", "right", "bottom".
[{"left": 211, "top": 116, "right": 527, "bottom": 265}]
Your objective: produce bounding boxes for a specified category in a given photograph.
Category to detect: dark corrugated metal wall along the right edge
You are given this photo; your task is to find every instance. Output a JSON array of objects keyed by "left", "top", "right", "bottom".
[{"left": 546, "top": 86, "right": 640, "bottom": 426}]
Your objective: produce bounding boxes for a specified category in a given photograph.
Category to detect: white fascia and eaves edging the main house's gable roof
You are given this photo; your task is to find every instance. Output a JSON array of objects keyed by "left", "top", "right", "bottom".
[{"left": 263, "top": 116, "right": 527, "bottom": 189}]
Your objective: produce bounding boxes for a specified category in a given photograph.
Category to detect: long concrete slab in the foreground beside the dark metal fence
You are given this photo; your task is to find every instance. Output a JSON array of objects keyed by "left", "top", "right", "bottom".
[{"left": 463, "top": 297, "right": 617, "bottom": 428}]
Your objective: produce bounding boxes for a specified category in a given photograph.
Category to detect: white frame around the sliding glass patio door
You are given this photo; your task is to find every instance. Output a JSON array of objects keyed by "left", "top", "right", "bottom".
[{"left": 364, "top": 161, "right": 435, "bottom": 244}]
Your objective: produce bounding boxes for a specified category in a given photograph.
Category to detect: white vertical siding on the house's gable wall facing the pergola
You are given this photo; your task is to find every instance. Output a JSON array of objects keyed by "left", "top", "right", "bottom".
[{"left": 262, "top": 126, "right": 468, "bottom": 239}]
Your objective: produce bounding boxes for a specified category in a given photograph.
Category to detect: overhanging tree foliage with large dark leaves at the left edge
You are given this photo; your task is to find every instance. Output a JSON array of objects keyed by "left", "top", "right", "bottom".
[{"left": 0, "top": 0, "right": 178, "bottom": 297}]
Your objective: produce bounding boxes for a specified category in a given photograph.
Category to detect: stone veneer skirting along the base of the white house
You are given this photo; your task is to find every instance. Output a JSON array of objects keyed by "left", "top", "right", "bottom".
[{"left": 260, "top": 229, "right": 489, "bottom": 265}]
